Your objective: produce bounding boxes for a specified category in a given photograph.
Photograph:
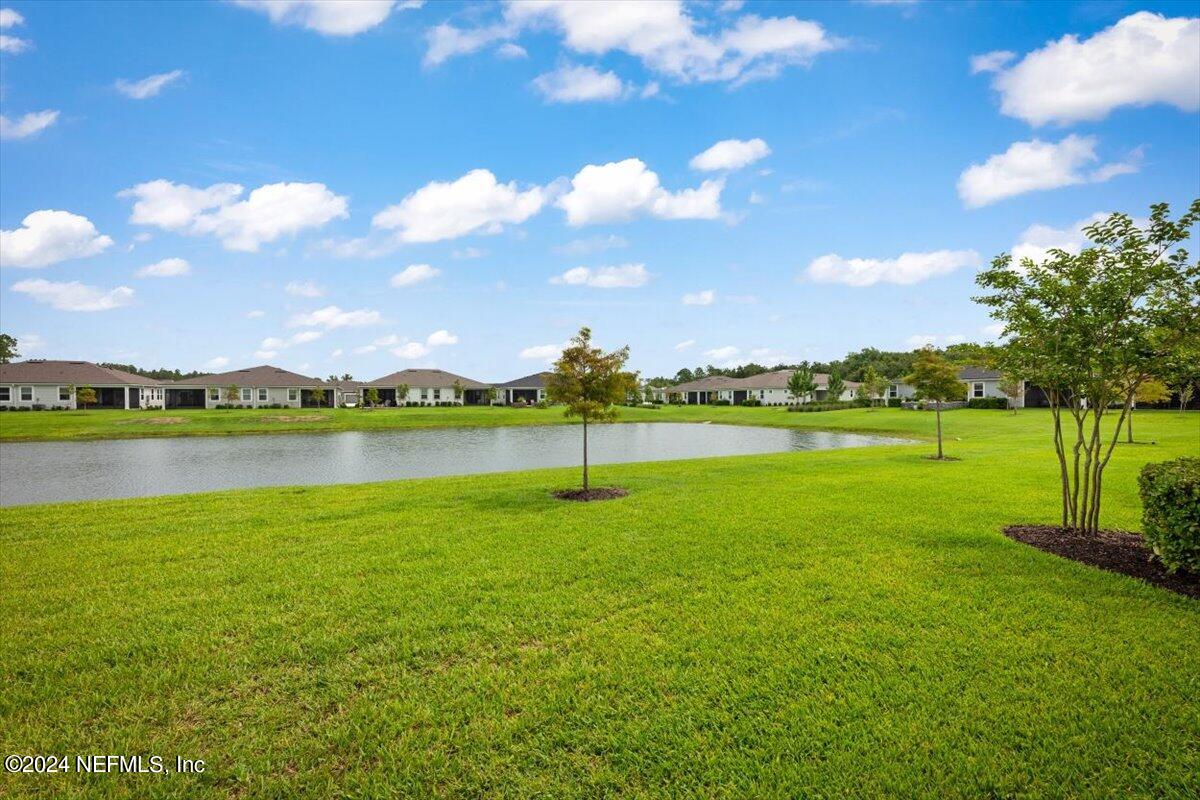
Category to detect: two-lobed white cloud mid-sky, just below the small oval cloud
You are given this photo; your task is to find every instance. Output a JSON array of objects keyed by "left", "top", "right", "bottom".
[{"left": 558, "top": 158, "right": 725, "bottom": 227}]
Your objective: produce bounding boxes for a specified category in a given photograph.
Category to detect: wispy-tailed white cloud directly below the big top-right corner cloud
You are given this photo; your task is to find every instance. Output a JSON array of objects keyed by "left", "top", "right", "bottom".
[{"left": 958, "top": 133, "right": 1141, "bottom": 209}]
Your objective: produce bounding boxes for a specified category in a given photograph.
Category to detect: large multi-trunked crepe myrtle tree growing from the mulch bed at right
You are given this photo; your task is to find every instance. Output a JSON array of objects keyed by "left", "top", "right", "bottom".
[{"left": 976, "top": 199, "right": 1200, "bottom": 534}]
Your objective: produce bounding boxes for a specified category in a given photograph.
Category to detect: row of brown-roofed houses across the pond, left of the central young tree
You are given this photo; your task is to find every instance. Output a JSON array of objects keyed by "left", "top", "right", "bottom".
[{"left": 0, "top": 360, "right": 550, "bottom": 409}]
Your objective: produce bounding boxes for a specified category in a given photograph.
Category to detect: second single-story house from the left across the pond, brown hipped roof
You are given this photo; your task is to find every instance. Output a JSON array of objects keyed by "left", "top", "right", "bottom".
[{"left": 166, "top": 365, "right": 334, "bottom": 408}]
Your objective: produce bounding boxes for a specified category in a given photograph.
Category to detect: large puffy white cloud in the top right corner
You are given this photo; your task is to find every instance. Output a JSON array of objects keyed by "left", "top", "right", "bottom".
[{"left": 992, "top": 11, "right": 1200, "bottom": 125}]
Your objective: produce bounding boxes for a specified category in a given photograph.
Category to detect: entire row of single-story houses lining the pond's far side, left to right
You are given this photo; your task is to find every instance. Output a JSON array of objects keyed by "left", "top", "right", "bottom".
[{"left": 0, "top": 360, "right": 1025, "bottom": 409}]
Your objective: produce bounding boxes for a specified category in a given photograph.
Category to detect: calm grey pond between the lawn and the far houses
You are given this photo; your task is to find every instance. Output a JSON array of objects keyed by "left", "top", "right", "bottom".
[{"left": 0, "top": 422, "right": 905, "bottom": 506}]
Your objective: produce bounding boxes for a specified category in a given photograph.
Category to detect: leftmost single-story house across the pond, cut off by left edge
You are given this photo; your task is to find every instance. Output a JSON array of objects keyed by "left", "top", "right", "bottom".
[{"left": 0, "top": 359, "right": 163, "bottom": 409}]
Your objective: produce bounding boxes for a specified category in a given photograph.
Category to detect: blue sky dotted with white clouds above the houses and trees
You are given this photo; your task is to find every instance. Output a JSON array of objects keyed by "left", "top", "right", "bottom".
[{"left": 0, "top": 1, "right": 1200, "bottom": 380}]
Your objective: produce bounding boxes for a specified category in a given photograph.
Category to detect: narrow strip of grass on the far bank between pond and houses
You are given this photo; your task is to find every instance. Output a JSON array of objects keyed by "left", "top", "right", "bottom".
[{"left": 0, "top": 405, "right": 1060, "bottom": 441}]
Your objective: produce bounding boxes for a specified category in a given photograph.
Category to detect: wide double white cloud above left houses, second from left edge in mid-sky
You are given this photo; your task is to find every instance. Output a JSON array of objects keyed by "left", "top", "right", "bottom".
[{"left": 118, "top": 179, "right": 349, "bottom": 252}]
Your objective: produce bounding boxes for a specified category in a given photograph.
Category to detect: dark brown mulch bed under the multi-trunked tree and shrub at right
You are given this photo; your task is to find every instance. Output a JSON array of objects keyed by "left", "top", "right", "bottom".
[{"left": 1004, "top": 525, "right": 1200, "bottom": 597}]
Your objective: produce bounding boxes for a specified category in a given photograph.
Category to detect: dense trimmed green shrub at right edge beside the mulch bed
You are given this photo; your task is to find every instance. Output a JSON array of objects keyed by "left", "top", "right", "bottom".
[{"left": 1138, "top": 458, "right": 1200, "bottom": 573}]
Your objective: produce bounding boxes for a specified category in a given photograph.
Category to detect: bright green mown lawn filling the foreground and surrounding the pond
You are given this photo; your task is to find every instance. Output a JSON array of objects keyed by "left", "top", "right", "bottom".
[{"left": 0, "top": 409, "right": 1200, "bottom": 798}]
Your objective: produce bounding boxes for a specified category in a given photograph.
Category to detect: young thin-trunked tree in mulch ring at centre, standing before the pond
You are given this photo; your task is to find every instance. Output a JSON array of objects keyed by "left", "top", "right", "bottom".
[{"left": 546, "top": 327, "right": 636, "bottom": 492}]
